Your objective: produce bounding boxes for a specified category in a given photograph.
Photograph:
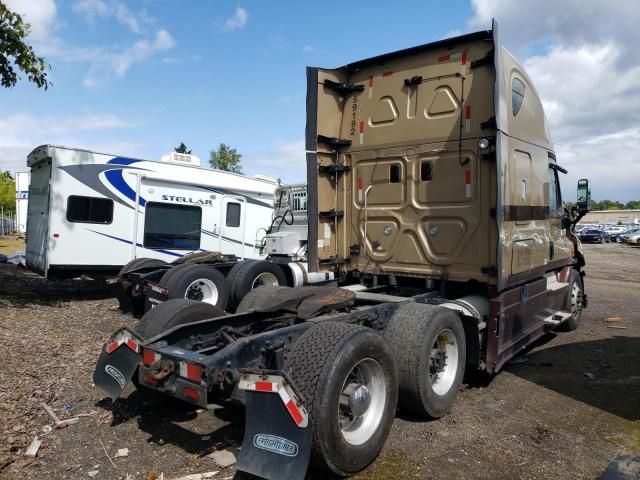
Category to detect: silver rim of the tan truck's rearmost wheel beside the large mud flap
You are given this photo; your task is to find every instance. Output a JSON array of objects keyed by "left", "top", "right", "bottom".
[{"left": 338, "top": 358, "right": 387, "bottom": 445}]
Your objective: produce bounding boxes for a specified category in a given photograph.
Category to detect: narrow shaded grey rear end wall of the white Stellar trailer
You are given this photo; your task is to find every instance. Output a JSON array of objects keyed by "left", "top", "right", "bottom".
[{"left": 27, "top": 158, "right": 51, "bottom": 276}]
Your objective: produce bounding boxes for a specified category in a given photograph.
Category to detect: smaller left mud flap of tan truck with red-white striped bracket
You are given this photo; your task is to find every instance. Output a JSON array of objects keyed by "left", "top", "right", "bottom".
[{"left": 93, "top": 327, "right": 142, "bottom": 400}]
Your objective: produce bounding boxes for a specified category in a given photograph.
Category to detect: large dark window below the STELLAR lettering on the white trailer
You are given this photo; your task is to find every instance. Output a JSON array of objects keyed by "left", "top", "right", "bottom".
[{"left": 144, "top": 202, "right": 202, "bottom": 250}]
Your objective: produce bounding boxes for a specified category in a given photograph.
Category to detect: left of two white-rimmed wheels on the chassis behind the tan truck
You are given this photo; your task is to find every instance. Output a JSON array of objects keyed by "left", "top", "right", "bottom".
[{"left": 160, "top": 264, "right": 229, "bottom": 310}]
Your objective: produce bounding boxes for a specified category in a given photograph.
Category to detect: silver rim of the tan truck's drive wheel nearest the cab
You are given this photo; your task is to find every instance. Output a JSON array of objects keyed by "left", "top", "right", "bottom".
[{"left": 429, "top": 328, "right": 458, "bottom": 396}]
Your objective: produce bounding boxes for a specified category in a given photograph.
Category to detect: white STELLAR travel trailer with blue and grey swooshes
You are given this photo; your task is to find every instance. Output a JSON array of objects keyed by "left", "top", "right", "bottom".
[{"left": 27, "top": 145, "right": 277, "bottom": 278}]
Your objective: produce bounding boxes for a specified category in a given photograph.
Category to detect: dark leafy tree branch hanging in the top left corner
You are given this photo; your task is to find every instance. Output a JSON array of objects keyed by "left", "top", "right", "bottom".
[{"left": 0, "top": 0, "right": 51, "bottom": 90}]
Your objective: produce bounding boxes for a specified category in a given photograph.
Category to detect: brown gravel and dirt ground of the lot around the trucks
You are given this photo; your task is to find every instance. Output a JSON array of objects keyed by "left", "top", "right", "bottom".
[{"left": 0, "top": 244, "right": 640, "bottom": 480}]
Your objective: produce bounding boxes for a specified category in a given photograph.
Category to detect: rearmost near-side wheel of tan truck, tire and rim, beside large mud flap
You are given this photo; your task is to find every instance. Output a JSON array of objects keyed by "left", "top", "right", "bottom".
[{"left": 286, "top": 322, "right": 398, "bottom": 476}]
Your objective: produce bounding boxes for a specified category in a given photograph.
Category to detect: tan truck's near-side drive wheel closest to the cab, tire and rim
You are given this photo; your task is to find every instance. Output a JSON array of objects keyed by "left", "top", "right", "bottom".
[{"left": 384, "top": 303, "right": 466, "bottom": 418}]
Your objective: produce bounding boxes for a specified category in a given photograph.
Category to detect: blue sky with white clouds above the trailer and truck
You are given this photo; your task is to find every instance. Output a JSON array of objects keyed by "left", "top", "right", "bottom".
[{"left": 0, "top": 0, "right": 640, "bottom": 200}]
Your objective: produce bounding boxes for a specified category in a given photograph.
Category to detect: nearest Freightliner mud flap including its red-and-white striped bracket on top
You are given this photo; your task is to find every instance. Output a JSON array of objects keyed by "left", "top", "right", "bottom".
[{"left": 237, "top": 374, "right": 311, "bottom": 480}]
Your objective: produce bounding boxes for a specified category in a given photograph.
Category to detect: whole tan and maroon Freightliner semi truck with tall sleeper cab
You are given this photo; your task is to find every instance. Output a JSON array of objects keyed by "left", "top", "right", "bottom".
[{"left": 94, "top": 23, "right": 590, "bottom": 479}]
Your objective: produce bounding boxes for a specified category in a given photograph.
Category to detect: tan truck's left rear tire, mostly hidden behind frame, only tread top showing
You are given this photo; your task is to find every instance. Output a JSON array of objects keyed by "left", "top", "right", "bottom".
[{"left": 136, "top": 298, "right": 224, "bottom": 340}]
